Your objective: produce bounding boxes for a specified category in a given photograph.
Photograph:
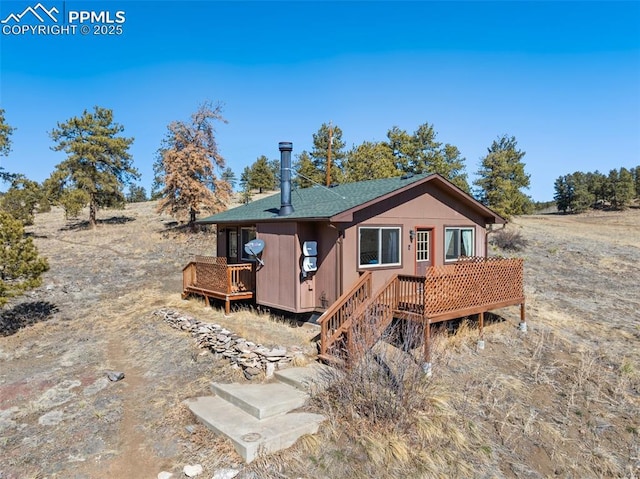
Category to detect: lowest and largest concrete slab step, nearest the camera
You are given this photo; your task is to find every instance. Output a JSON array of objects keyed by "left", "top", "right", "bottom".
[{"left": 185, "top": 396, "right": 325, "bottom": 463}]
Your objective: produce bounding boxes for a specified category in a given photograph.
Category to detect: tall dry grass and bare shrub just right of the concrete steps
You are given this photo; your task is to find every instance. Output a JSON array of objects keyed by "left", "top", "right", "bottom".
[{"left": 252, "top": 322, "right": 496, "bottom": 478}]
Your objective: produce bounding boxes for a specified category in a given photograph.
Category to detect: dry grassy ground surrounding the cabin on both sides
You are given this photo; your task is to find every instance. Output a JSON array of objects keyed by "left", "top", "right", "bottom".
[{"left": 0, "top": 204, "right": 640, "bottom": 479}]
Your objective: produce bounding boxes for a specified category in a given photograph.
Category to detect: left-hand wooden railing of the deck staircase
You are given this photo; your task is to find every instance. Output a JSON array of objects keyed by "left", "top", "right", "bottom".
[{"left": 318, "top": 271, "right": 371, "bottom": 356}]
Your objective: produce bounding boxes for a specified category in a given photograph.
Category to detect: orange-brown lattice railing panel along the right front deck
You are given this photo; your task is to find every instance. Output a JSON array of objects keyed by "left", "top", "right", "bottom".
[{"left": 424, "top": 258, "right": 524, "bottom": 321}]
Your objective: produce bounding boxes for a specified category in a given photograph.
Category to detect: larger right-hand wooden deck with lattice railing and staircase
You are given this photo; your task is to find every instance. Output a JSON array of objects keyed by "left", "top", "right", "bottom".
[{"left": 319, "top": 258, "right": 525, "bottom": 368}]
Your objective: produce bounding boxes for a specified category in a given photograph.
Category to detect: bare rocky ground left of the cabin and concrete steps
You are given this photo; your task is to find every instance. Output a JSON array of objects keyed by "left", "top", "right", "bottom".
[{"left": 0, "top": 203, "right": 316, "bottom": 479}]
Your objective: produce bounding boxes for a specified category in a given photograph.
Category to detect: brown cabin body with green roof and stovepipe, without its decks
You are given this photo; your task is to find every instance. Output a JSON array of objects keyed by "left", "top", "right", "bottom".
[{"left": 199, "top": 143, "right": 505, "bottom": 313}]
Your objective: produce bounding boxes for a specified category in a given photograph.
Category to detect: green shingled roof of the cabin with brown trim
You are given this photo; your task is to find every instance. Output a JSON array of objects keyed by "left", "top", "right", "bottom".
[{"left": 198, "top": 174, "right": 505, "bottom": 224}]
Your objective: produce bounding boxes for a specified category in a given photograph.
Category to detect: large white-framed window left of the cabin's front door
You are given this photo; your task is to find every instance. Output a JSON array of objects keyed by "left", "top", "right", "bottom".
[{"left": 359, "top": 227, "right": 400, "bottom": 268}]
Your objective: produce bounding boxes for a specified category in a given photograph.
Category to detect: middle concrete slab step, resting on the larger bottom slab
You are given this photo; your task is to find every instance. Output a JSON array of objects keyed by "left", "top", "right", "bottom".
[{"left": 211, "top": 382, "right": 309, "bottom": 419}]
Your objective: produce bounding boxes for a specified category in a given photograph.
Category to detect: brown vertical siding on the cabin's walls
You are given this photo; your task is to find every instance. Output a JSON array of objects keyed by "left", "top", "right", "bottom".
[{"left": 218, "top": 183, "right": 496, "bottom": 313}]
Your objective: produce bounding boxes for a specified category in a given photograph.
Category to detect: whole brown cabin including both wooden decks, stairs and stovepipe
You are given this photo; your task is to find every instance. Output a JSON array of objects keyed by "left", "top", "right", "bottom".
[{"left": 189, "top": 143, "right": 526, "bottom": 364}]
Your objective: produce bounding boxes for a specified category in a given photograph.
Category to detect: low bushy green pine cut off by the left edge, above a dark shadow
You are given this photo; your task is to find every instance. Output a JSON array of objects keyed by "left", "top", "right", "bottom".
[{"left": 0, "top": 212, "right": 49, "bottom": 308}]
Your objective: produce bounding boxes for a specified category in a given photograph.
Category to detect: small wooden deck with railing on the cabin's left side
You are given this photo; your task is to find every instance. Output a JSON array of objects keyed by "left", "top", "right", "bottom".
[{"left": 182, "top": 256, "right": 255, "bottom": 314}]
